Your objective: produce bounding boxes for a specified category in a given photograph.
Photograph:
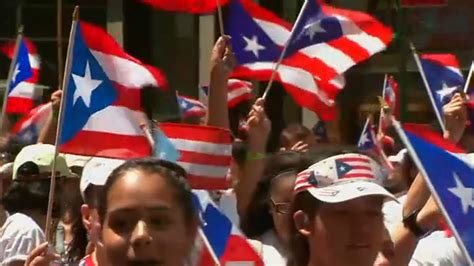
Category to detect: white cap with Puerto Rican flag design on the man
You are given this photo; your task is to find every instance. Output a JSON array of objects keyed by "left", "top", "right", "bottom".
[{"left": 294, "top": 153, "right": 396, "bottom": 203}]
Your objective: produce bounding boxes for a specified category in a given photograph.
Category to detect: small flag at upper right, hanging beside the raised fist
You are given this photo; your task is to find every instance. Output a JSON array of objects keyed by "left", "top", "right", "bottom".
[{"left": 420, "top": 54, "right": 465, "bottom": 130}]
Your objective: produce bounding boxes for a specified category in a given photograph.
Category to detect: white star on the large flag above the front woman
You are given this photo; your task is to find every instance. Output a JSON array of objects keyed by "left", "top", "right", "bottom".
[{"left": 72, "top": 61, "right": 103, "bottom": 108}]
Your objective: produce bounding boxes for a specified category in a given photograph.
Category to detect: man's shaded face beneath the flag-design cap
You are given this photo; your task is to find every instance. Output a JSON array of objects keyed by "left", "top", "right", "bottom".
[{"left": 308, "top": 196, "right": 384, "bottom": 266}]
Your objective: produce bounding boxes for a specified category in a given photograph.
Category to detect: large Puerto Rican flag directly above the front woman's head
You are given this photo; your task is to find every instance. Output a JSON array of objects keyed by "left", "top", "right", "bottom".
[{"left": 60, "top": 21, "right": 167, "bottom": 159}]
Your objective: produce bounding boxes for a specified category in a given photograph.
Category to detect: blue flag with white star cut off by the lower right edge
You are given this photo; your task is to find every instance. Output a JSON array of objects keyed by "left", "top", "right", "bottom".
[{"left": 395, "top": 123, "right": 474, "bottom": 265}]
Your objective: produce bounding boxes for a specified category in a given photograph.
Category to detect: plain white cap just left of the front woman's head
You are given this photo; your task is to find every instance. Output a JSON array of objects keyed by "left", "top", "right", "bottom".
[{"left": 79, "top": 157, "right": 125, "bottom": 199}]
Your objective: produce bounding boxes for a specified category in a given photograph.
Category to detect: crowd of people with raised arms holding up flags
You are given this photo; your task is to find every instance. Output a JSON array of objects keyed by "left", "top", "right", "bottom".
[{"left": 0, "top": 37, "right": 471, "bottom": 266}]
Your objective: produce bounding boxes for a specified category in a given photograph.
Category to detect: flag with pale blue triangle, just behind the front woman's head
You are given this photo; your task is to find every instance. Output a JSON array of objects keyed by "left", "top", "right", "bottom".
[{"left": 155, "top": 123, "right": 232, "bottom": 190}]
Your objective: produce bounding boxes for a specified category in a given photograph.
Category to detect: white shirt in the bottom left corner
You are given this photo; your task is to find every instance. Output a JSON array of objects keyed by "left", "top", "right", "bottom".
[{"left": 0, "top": 213, "right": 46, "bottom": 265}]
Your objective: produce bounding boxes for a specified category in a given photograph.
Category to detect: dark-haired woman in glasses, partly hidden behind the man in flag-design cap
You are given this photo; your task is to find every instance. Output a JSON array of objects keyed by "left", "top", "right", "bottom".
[{"left": 241, "top": 151, "right": 311, "bottom": 265}]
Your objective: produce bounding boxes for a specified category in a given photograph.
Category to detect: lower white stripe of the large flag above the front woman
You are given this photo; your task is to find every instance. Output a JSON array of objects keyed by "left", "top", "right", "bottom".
[{"left": 84, "top": 106, "right": 147, "bottom": 136}]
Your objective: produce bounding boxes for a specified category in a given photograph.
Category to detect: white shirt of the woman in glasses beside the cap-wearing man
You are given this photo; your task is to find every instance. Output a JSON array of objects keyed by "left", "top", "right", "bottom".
[{"left": 250, "top": 230, "right": 287, "bottom": 266}]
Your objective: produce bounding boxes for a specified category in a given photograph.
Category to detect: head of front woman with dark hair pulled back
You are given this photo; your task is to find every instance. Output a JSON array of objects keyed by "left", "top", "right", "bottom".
[{"left": 98, "top": 159, "right": 198, "bottom": 266}]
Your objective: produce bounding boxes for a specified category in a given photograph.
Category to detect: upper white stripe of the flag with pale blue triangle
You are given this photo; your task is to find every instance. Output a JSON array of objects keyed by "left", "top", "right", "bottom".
[{"left": 170, "top": 138, "right": 232, "bottom": 156}]
